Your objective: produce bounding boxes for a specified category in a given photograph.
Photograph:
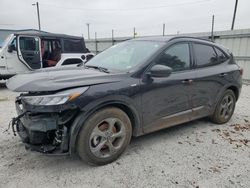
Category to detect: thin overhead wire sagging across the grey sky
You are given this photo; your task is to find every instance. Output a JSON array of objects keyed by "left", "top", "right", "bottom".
[{"left": 40, "top": 0, "right": 211, "bottom": 11}]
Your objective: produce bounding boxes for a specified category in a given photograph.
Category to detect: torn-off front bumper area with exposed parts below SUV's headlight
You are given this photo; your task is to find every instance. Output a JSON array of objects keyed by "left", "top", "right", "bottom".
[{"left": 12, "top": 97, "right": 77, "bottom": 155}]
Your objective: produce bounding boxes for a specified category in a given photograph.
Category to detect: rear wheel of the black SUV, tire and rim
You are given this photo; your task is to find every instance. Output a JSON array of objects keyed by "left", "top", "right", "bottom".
[{"left": 211, "top": 89, "right": 236, "bottom": 124}]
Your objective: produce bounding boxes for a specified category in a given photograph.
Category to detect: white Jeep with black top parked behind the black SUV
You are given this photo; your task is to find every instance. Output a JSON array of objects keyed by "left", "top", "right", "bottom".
[{"left": 0, "top": 31, "right": 94, "bottom": 79}]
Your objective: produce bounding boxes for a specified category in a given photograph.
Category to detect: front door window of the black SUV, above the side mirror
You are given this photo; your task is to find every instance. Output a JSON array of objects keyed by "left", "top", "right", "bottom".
[{"left": 156, "top": 43, "right": 190, "bottom": 71}]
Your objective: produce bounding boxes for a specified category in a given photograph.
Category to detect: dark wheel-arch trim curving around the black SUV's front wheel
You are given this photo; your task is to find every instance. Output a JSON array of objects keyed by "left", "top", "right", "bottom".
[{"left": 69, "top": 95, "right": 143, "bottom": 154}]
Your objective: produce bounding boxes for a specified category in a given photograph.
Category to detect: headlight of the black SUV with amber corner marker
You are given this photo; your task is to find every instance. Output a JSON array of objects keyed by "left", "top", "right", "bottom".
[{"left": 22, "top": 87, "right": 89, "bottom": 106}]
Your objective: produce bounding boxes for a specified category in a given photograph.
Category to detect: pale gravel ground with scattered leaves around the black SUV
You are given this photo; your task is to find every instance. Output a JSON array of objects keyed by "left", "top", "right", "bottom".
[{"left": 0, "top": 84, "right": 250, "bottom": 188}]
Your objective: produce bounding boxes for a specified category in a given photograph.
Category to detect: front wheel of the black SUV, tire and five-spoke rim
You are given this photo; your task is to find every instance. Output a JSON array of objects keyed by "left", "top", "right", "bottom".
[{"left": 76, "top": 107, "right": 132, "bottom": 165}]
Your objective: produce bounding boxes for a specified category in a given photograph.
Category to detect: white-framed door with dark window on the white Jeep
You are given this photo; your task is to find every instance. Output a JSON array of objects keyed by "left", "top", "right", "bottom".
[{"left": 18, "top": 36, "right": 42, "bottom": 69}]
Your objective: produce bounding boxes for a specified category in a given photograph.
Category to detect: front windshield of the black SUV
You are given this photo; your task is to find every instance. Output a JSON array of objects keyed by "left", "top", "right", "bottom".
[{"left": 86, "top": 41, "right": 164, "bottom": 72}]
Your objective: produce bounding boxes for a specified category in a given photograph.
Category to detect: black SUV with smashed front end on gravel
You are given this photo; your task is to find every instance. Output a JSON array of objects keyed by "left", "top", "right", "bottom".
[{"left": 7, "top": 37, "right": 242, "bottom": 165}]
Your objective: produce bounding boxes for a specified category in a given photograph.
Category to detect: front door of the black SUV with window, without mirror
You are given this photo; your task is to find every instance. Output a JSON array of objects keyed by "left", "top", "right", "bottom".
[{"left": 141, "top": 43, "right": 195, "bottom": 133}]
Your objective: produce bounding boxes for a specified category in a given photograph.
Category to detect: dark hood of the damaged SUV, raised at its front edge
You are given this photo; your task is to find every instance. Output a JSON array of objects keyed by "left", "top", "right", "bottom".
[{"left": 6, "top": 67, "right": 122, "bottom": 92}]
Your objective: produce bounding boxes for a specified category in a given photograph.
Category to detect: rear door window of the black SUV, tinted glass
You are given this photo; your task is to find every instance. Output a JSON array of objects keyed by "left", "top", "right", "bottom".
[{"left": 194, "top": 44, "right": 218, "bottom": 67}]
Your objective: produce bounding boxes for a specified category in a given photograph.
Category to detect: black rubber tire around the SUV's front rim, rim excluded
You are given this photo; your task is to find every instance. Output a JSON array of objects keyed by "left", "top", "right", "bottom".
[{"left": 76, "top": 107, "right": 132, "bottom": 165}]
